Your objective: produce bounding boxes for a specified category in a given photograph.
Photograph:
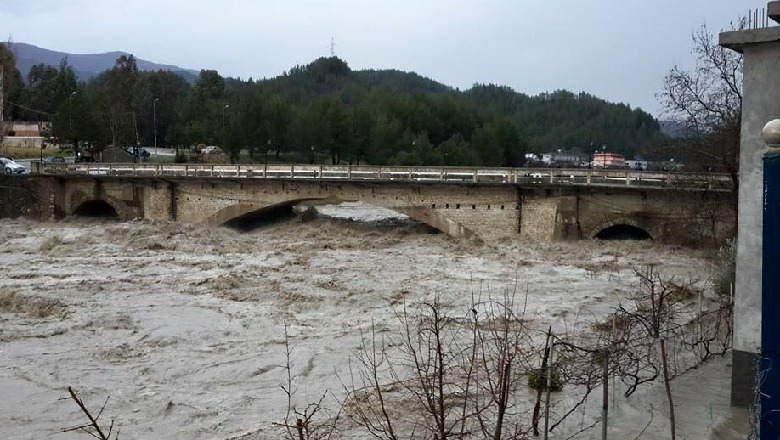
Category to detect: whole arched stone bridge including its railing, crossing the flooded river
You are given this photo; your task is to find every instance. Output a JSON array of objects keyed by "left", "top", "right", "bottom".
[{"left": 34, "top": 164, "right": 735, "bottom": 244}]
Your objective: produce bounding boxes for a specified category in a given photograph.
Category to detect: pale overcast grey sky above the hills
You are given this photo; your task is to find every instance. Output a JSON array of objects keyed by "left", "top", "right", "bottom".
[{"left": 0, "top": 0, "right": 766, "bottom": 115}]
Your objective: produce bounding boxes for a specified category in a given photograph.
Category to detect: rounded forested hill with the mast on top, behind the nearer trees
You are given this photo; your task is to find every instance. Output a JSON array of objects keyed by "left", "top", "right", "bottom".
[{"left": 248, "top": 58, "right": 663, "bottom": 164}]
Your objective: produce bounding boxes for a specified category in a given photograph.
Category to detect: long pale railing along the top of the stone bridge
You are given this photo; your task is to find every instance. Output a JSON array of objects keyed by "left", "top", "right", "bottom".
[{"left": 32, "top": 163, "right": 732, "bottom": 191}]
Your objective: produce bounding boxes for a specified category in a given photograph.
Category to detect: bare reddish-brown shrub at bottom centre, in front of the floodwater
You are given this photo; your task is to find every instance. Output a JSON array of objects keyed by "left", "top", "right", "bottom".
[{"left": 344, "top": 292, "right": 537, "bottom": 440}]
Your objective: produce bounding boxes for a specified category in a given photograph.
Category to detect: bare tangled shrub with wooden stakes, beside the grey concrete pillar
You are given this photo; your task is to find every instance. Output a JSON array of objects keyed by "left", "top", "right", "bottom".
[{"left": 550, "top": 266, "right": 733, "bottom": 438}]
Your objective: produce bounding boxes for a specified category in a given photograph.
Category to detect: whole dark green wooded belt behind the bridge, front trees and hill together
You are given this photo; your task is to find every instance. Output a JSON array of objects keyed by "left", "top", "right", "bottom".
[{"left": 6, "top": 45, "right": 663, "bottom": 166}]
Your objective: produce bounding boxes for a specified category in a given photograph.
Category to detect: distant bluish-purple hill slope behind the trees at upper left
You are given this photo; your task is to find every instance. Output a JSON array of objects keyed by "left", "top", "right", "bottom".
[{"left": 11, "top": 43, "right": 198, "bottom": 82}]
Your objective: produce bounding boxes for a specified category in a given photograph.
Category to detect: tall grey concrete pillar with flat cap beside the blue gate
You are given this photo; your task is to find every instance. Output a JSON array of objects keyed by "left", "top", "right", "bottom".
[{"left": 720, "top": 7, "right": 780, "bottom": 407}]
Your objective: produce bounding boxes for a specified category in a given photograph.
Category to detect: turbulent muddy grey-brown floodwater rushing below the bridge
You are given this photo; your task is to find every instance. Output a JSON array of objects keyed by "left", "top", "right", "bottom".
[{"left": 0, "top": 203, "right": 741, "bottom": 440}]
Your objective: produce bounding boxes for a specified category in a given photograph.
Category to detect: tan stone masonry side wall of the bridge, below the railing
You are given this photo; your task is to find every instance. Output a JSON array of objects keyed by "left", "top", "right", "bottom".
[{"left": 51, "top": 178, "right": 734, "bottom": 244}]
